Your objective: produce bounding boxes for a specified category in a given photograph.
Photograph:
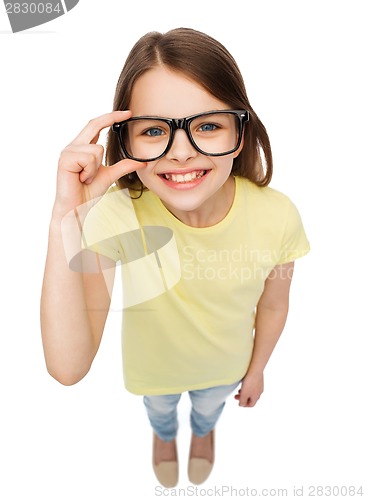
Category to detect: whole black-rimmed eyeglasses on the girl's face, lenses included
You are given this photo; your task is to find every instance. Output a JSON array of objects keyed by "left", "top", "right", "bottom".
[{"left": 112, "top": 109, "right": 249, "bottom": 162}]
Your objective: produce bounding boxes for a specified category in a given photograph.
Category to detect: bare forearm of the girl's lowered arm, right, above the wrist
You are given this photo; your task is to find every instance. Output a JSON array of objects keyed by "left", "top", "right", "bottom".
[{"left": 248, "top": 304, "right": 288, "bottom": 373}]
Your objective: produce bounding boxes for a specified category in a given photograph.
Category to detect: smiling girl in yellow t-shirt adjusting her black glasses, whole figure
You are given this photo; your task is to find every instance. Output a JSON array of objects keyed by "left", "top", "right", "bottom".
[{"left": 41, "top": 29, "right": 309, "bottom": 487}]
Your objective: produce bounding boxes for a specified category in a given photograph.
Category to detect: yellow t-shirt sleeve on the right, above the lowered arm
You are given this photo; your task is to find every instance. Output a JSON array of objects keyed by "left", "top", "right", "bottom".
[{"left": 277, "top": 199, "right": 310, "bottom": 264}]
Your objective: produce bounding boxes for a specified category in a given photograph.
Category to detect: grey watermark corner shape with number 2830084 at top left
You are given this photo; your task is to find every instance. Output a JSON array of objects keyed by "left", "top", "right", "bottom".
[{"left": 4, "top": 0, "right": 79, "bottom": 33}]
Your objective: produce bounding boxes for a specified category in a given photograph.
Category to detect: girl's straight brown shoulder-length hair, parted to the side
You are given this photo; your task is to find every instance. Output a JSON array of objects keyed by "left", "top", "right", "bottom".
[{"left": 106, "top": 28, "right": 273, "bottom": 194}]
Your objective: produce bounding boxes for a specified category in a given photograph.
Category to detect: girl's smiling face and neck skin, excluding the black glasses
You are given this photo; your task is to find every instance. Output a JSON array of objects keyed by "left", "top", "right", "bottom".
[{"left": 129, "top": 66, "right": 243, "bottom": 225}]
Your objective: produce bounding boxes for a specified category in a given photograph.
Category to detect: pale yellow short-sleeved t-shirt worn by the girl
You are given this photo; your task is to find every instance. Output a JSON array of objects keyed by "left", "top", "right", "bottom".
[{"left": 83, "top": 177, "right": 309, "bottom": 395}]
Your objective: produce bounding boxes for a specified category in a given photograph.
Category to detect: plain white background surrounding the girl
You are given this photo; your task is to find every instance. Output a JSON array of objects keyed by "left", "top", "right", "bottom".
[{"left": 0, "top": 0, "right": 365, "bottom": 500}]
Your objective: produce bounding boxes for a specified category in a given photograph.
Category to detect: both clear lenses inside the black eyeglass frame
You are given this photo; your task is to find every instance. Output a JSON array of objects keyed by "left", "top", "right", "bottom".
[{"left": 123, "top": 113, "right": 239, "bottom": 159}]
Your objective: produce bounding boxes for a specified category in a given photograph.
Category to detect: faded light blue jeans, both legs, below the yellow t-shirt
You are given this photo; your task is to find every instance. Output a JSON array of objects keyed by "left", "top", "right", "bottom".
[{"left": 143, "top": 380, "right": 240, "bottom": 441}]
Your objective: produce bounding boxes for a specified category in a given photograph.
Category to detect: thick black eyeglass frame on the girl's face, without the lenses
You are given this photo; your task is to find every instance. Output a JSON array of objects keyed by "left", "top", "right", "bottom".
[{"left": 112, "top": 109, "right": 250, "bottom": 162}]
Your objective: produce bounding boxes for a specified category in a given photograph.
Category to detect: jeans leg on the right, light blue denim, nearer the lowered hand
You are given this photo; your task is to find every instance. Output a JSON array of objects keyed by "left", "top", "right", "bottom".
[{"left": 189, "top": 380, "right": 240, "bottom": 437}]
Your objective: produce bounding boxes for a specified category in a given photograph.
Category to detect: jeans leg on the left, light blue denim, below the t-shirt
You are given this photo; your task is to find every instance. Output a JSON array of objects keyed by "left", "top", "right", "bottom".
[{"left": 143, "top": 394, "right": 181, "bottom": 441}]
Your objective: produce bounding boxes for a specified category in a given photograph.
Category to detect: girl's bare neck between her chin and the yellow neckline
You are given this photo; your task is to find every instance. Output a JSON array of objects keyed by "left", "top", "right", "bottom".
[{"left": 165, "top": 177, "right": 235, "bottom": 227}]
